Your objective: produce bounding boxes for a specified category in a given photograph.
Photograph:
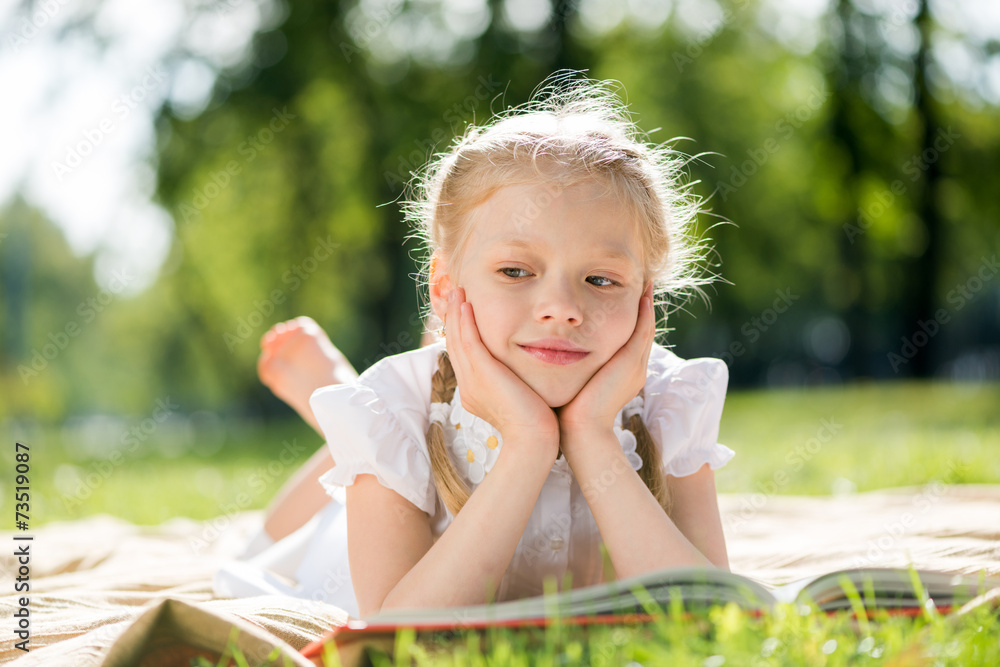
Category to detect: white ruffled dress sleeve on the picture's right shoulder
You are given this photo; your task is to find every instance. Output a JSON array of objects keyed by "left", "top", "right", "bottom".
[{"left": 644, "top": 345, "right": 736, "bottom": 477}]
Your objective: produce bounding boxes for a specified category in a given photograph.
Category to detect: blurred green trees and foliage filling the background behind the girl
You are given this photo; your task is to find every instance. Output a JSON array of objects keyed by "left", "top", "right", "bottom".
[{"left": 0, "top": 0, "right": 1000, "bottom": 420}]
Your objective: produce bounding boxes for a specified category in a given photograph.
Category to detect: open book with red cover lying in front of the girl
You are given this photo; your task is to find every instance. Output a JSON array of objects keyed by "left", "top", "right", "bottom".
[{"left": 303, "top": 568, "right": 1000, "bottom": 656}]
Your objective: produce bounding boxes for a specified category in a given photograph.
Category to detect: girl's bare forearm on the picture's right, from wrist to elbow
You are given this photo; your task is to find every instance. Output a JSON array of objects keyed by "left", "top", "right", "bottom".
[{"left": 563, "top": 433, "right": 712, "bottom": 578}]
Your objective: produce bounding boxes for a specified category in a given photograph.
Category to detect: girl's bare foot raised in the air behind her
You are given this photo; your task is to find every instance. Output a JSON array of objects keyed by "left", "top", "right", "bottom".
[{"left": 257, "top": 316, "right": 358, "bottom": 431}]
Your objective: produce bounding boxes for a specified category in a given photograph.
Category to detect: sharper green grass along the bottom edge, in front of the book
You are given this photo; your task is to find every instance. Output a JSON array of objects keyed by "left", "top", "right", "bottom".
[{"left": 198, "top": 592, "right": 1000, "bottom": 667}]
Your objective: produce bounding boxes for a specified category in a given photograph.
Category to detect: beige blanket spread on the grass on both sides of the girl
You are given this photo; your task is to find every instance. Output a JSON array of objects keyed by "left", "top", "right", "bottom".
[{"left": 0, "top": 485, "right": 1000, "bottom": 667}]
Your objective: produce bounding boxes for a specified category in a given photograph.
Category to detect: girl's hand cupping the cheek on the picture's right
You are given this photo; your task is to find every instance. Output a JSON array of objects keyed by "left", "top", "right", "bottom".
[{"left": 558, "top": 283, "right": 656, "bottom": 443}]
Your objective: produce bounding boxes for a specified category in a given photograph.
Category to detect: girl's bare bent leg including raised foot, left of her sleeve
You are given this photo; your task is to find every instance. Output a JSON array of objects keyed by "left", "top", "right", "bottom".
[{"left": 257, "top": 317, "right": 358, "bottom": 540}]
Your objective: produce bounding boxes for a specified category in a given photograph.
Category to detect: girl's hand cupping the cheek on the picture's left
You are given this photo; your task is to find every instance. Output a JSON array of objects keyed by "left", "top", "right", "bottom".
[{"left": 445, "top": 287, "right": 559, "bottom": 461}]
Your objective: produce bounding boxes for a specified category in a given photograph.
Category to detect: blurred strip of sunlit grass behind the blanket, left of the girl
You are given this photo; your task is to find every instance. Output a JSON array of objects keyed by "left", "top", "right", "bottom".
[{"left": 0, "top": 420, "right": 323, "bottom": 526}]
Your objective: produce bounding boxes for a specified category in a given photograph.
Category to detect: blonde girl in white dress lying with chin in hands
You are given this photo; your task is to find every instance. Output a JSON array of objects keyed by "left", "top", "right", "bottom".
[{"left": 216, "top": 75, "right": 733, "bottom": 616}]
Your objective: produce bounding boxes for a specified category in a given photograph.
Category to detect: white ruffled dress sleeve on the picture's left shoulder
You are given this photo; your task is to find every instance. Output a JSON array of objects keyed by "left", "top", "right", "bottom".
[{"left": 309, "top": 384, "right": 437, "bottom": 516}]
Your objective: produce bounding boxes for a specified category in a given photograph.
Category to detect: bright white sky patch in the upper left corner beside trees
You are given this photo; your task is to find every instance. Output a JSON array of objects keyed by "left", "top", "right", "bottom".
[{"left": 0, "top": 0, "right": 270, "bottom": 293}]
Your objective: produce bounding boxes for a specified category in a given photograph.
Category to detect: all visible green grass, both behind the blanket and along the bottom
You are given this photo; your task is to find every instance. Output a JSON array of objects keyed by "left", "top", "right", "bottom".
[{"left": 7, "top": 383, "right": 1000, "bottom": 667}]
